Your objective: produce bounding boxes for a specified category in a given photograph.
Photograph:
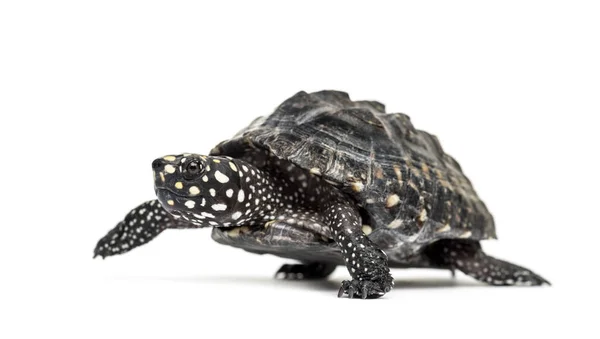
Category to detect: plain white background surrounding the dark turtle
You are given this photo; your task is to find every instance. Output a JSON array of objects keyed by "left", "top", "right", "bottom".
[{"left": 0, "top": 0, "right": 600, "bottom": 338}]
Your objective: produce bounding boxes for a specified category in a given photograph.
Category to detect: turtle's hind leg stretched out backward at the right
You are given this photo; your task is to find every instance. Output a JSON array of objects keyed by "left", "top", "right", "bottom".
[{"left": 427, "top": 239, "right": 550, "bottom": 286}]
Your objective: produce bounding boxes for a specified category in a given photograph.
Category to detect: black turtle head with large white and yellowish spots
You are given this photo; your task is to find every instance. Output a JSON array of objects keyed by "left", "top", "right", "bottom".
[{"left": 152, "top": 154, "right": 245, "bottom": 227}]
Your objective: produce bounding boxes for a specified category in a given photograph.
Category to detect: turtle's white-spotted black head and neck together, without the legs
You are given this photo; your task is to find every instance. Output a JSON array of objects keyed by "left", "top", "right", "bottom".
[{"left": 153, "top": 154, "right": 328, "bottom": 231}]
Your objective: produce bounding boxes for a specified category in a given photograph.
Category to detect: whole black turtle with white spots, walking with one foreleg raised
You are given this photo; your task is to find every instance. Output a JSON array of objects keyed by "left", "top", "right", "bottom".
[{"left": 94, "top": 90, "right": 549, "bottom": 299}]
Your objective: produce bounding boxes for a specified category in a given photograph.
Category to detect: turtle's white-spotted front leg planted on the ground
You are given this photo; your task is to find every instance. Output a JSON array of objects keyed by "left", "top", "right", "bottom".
[{"left": 325, "top": 199, "right": 394, "bottom": 299}]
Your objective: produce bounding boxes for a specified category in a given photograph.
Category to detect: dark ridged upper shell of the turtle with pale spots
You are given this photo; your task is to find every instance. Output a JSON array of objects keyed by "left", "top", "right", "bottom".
[{"left": 211, "top": 91, "right": 495, "bottom": 255}]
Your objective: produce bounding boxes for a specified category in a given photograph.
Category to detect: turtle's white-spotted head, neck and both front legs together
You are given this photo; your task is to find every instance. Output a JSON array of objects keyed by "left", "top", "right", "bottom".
[{"left": 95, "top": 154, "right": 393, "bottom": 298}]
